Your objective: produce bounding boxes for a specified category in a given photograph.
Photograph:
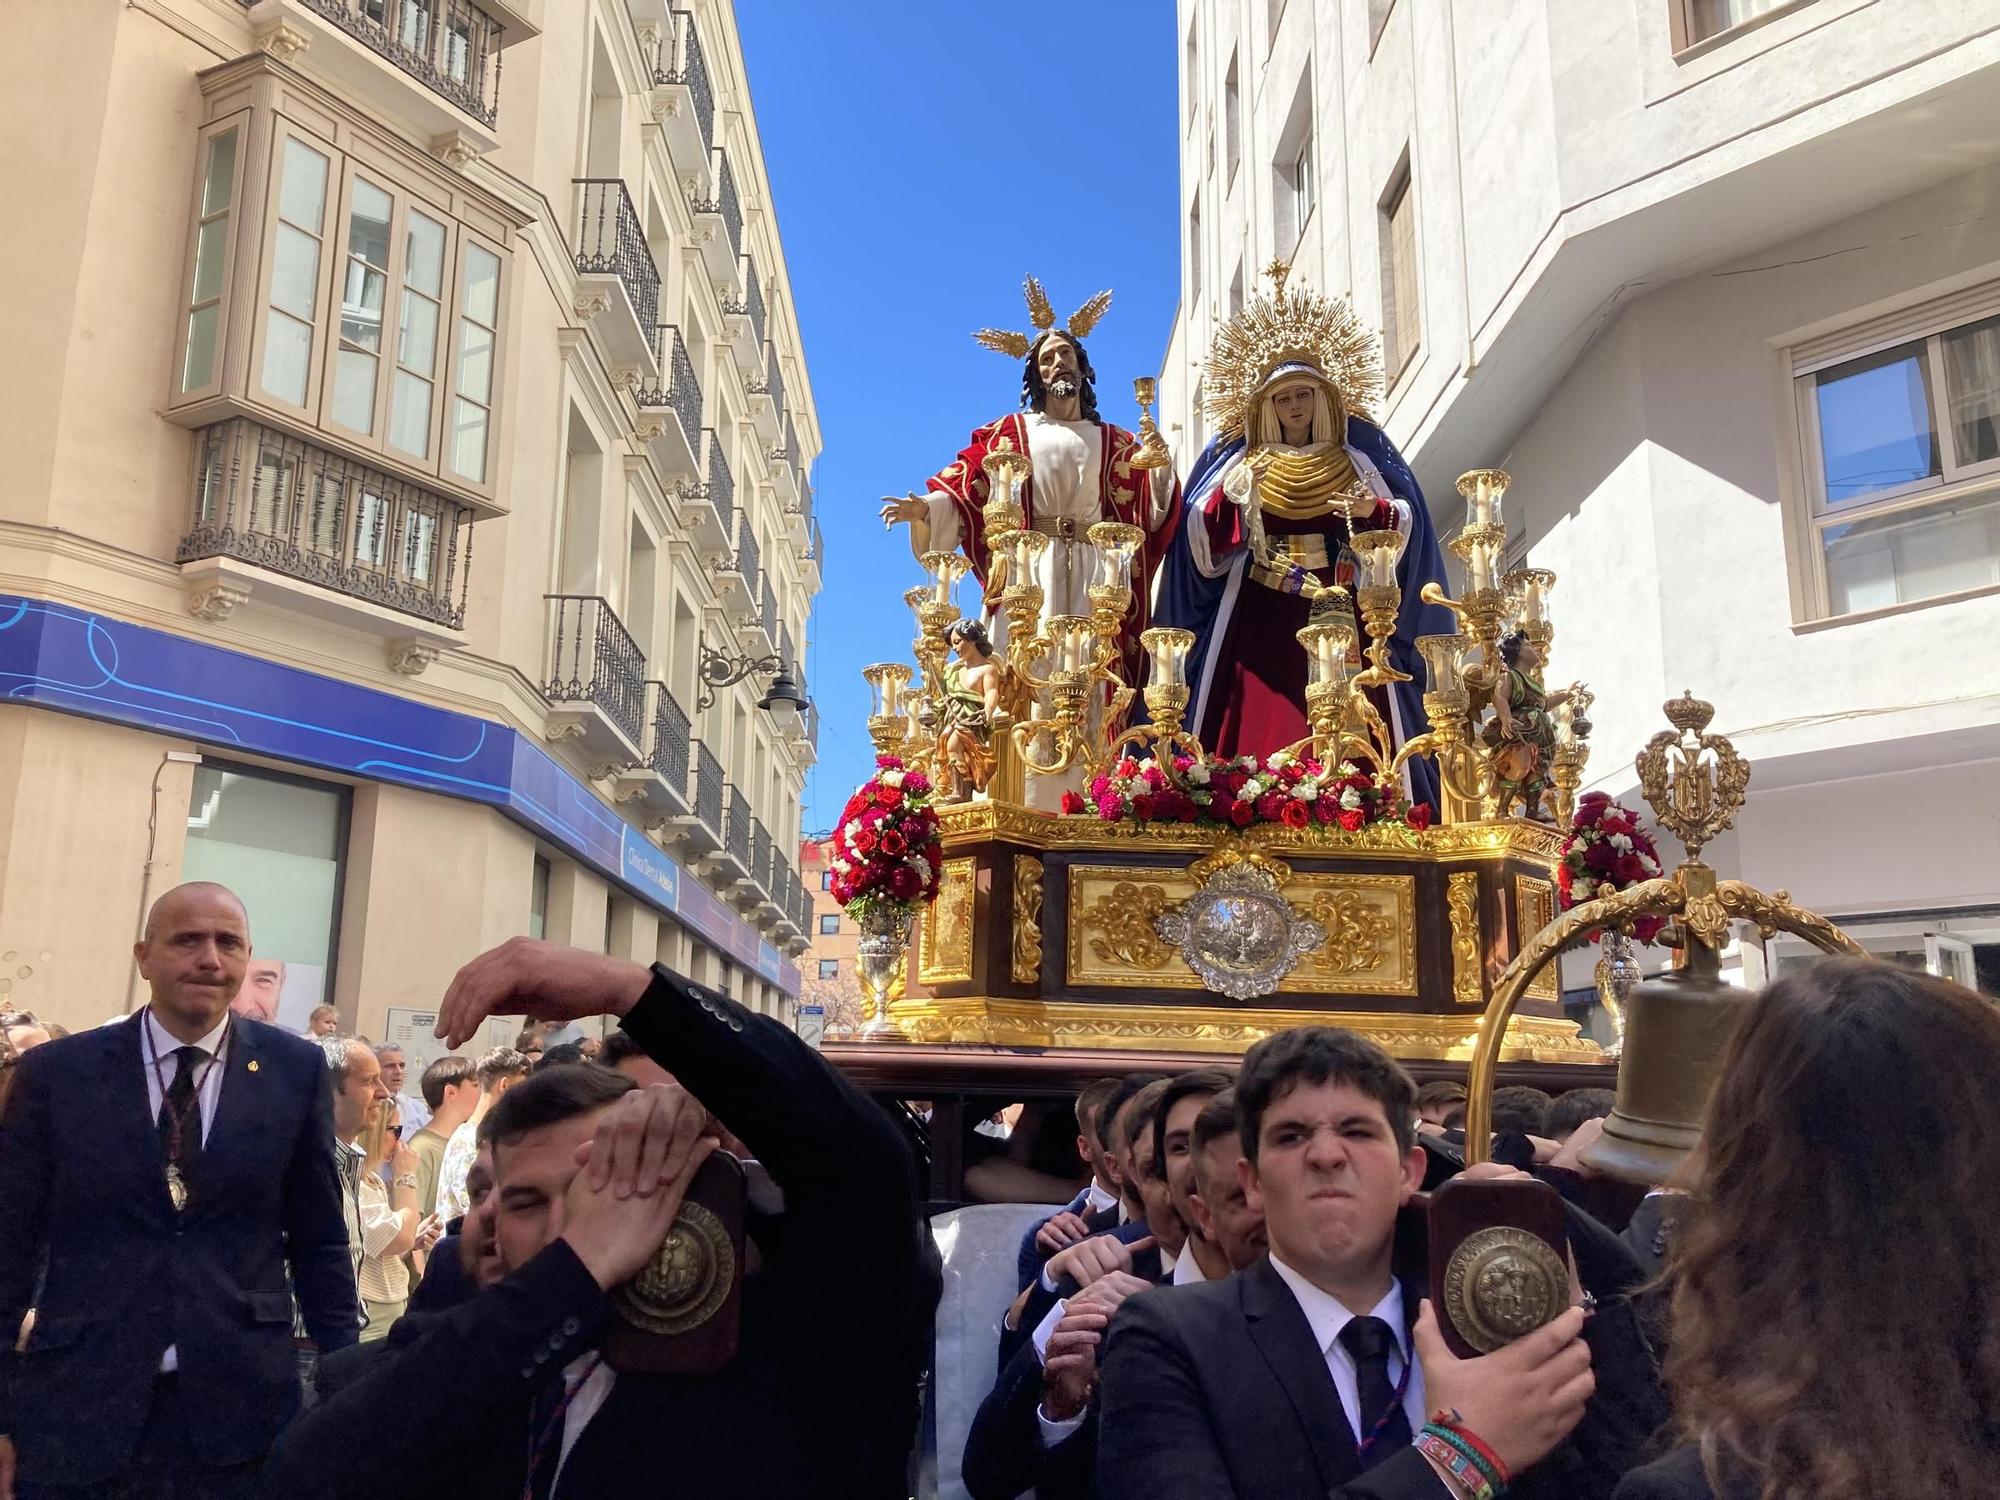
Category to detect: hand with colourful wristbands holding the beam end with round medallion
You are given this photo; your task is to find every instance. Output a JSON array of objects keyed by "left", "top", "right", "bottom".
[{"left": 1416, "top": 1302, "right": 1596, "bottom": 1474}]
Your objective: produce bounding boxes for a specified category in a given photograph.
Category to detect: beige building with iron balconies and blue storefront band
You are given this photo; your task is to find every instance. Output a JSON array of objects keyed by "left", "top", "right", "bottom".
[{"left": 0, "top": 0, "right": 824, "bottom": 1036}]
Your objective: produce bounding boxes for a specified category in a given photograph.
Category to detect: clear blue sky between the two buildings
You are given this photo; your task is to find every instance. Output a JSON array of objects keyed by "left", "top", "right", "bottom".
[{"left": 736, "top": 0, "right": 1180, "bottom": 832}]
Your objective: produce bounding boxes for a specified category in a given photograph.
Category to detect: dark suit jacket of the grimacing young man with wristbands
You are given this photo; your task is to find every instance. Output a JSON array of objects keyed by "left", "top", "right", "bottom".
[{"left": 1098, "top": 1214, "right": 1664, "bottom": 1500}]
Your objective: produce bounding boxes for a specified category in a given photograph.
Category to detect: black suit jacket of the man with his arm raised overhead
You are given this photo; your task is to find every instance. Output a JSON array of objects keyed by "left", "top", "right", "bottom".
[{"left": 266, "top": 968, "right": 938, "bottom": 1500}]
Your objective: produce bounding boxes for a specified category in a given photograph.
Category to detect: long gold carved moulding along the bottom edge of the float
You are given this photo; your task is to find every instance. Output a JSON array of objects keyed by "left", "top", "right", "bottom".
[{"left": 896, "top": 996, "right": 1606, "bottom": 1064}]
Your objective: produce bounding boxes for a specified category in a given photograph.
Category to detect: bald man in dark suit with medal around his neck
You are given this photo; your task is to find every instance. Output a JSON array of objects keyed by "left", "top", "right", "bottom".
[{"left": 0, "top": 884, "right": 358, "bottom": 1500}]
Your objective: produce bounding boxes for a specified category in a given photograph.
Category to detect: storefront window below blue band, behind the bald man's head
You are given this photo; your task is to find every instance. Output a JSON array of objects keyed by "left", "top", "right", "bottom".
[{"left": 180, "top": 762, "right": 348, "bottom": 1032}]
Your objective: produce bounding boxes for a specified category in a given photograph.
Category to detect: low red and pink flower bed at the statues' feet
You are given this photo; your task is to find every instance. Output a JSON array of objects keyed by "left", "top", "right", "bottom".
[{"left": 1062, "top": 750, "right": 1430, "bottom": 832}]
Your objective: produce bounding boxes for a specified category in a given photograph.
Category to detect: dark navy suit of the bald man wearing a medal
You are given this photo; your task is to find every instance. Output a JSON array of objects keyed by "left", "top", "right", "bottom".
[{"left": 0, "top": 1016, "right": 358, "bottom": 1484}]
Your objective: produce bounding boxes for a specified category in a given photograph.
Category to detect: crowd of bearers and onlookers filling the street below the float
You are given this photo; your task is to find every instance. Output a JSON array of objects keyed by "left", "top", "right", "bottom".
[{"left": 0, "top": 884, "right": 2000, "bottom": 1500}]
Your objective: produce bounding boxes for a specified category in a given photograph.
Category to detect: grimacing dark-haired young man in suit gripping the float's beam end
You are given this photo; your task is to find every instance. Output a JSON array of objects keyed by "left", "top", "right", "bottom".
[{"left": 1098, "top": 1026, "right": 1652, "bottom": 1500}]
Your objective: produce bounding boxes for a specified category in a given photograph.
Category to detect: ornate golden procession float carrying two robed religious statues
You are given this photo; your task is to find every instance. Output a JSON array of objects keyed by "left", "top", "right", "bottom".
[{"left": 824, "top": 262, "right": 1846, "bottom": 1198}]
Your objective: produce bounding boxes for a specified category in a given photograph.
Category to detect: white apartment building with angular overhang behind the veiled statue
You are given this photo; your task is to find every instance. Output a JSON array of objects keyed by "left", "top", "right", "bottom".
[{"left": 1160, "top": 0, "right": 2000, "bottom": 992}]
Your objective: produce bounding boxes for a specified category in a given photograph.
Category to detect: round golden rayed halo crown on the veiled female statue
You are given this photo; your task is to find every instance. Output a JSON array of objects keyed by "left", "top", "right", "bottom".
[{"left": 1202, "top": 260, "right": 1382, "bottom": 436}]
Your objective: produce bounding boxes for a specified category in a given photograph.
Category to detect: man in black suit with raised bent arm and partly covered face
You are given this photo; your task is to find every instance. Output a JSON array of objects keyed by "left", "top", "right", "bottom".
[{"left": 268, "top": 938, "right": 938, "bottom": 1500}]
